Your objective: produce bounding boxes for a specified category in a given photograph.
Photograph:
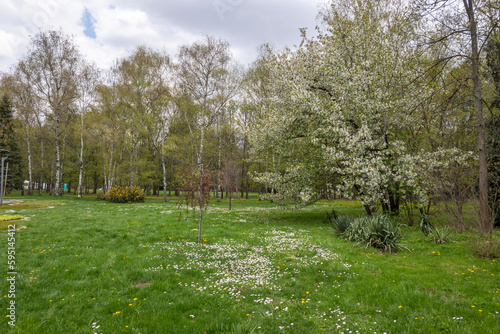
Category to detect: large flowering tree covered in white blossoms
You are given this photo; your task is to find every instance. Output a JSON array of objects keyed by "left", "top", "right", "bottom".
[{"left": 250, "top": 0, "right": 472, "bottom": 214}]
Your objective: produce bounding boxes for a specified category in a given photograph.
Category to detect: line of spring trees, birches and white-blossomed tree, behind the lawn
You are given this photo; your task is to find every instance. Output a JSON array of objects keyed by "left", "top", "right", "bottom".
[{"left": 1, "top": 0, "right": 500, "bottom": 233}]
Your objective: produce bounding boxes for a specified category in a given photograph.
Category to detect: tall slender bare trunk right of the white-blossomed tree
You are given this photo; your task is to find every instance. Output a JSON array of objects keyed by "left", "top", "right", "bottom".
[{"left": 463, "top": 0, "right": 493, "bottom": 234}]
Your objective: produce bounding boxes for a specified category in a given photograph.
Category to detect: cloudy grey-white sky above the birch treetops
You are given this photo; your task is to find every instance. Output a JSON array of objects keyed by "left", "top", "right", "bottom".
[{"left": 0, "top": 0, "right": 318, "bottom": 72}]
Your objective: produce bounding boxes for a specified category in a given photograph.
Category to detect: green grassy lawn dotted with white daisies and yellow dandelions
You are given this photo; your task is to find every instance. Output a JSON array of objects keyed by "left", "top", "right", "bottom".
[{"left": 0, "top": 196, "right": 500, "bottom": 334}]
